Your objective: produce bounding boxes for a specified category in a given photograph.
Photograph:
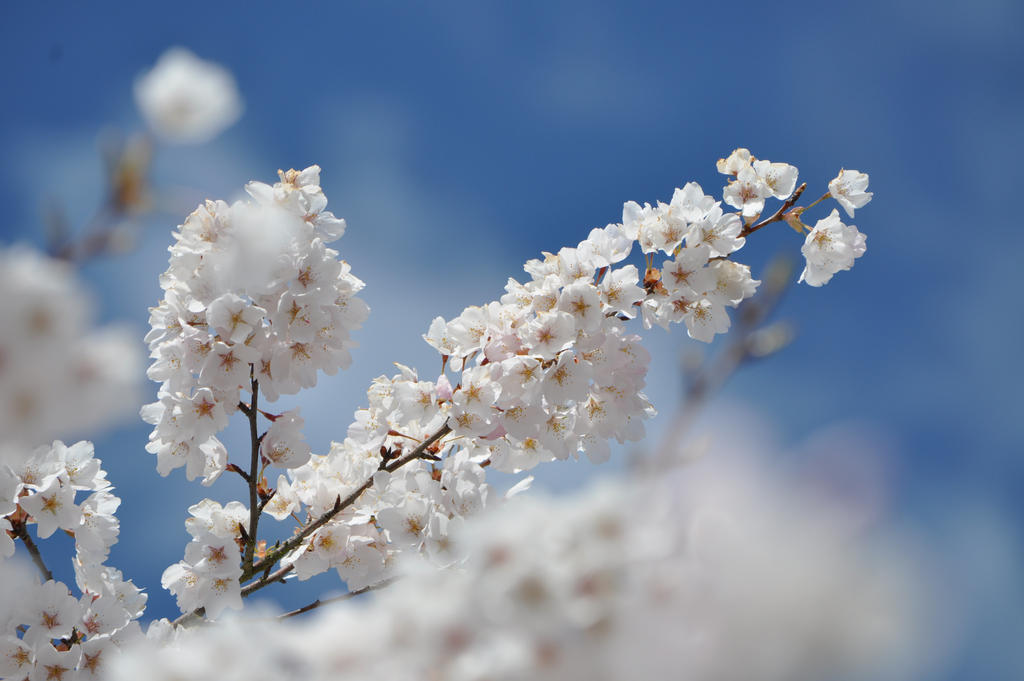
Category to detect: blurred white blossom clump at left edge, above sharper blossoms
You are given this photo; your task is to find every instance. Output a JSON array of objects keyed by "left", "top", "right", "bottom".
[{"left": 0, "top": 247, "right": 142, "bottom": 466}]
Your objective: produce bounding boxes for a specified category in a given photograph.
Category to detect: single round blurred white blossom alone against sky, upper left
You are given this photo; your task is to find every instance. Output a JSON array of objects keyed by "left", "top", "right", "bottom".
[{"left": 135, "top": 47, "right": 243, "bottom": 144}]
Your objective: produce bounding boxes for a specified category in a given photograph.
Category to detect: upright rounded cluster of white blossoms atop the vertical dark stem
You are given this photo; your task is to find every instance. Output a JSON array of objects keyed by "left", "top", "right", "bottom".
[{"left": 142, "top": 166, "right": 369, "bottom": 484}]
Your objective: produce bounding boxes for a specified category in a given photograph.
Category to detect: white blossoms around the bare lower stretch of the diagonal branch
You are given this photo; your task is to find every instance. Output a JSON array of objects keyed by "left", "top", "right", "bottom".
[{"left": 266, "top": 374, "right": 490, "bottom": 589}]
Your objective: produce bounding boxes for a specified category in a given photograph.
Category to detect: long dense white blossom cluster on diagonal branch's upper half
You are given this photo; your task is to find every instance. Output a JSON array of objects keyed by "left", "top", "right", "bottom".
[{"left": 419, "top": 150, "right": 851, "bottom": 471}]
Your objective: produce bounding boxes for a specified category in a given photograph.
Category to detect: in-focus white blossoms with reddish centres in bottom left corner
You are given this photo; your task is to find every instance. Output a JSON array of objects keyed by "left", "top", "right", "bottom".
[{"left": 0, "top": 441, "right": 146, "bottom": 681}]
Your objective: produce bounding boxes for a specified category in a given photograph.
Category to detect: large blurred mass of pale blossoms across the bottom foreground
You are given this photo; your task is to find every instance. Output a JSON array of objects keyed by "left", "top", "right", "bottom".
[{"left": 112, "top": 440, "right": 923, "bottom": 681}]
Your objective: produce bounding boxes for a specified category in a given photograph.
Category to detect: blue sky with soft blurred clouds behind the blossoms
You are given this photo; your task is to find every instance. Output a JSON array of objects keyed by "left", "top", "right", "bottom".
[{"left": 0, "top": 0, "right": 1024, "bottom": 679}]
